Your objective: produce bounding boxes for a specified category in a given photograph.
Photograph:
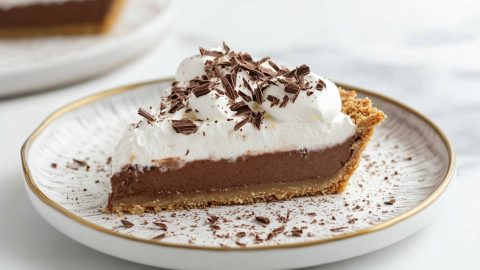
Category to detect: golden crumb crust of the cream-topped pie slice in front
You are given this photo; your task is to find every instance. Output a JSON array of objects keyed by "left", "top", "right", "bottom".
[{"left": 107, "top": 88, "right": 386, "bottom": 214}]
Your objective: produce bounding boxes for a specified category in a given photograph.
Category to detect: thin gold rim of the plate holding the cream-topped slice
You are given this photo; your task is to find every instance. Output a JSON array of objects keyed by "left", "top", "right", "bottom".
[{"left": 21, "top": 78, "right": 456, "bottom": 251}]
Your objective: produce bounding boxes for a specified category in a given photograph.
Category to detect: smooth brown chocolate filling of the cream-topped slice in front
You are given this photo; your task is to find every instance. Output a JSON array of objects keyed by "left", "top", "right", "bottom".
[{"left": 109, "top": 136, "right": 356, "bottom": 210}]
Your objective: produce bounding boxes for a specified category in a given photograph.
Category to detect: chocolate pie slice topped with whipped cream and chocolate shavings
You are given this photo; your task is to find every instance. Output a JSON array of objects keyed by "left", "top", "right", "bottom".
[{"left": 107, "top": 44, "right": 385, "bottom": 214}]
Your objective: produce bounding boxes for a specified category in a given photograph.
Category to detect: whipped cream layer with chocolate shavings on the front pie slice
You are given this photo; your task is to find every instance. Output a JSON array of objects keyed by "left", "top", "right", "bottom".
[{"left": 113, "top": 44, "right": 355, "bottom": 173}]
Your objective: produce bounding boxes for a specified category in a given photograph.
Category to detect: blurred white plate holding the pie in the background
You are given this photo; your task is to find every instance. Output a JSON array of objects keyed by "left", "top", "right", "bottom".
[{"left": 0, "top": 0, "right": 173, "bottom": 97}]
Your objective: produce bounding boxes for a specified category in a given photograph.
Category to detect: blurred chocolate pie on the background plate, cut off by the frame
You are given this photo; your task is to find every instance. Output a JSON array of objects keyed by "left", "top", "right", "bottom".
[{"left": 0, "top": 0, "right": 124, "bottom": 37}]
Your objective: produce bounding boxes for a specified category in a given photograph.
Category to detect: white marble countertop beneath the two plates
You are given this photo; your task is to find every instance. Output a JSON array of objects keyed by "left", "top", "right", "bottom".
[{"left": 0, "top": 0, "right": 480, "bottom": 270}]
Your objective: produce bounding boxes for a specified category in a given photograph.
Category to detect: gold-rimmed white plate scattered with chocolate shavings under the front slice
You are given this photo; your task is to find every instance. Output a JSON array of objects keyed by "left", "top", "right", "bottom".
[{"left": 22, "top": 80, "right": 455, "bottom": 269}]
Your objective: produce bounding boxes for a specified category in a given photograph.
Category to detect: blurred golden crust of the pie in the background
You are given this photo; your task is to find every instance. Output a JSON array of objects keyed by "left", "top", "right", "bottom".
[{"left": 0, "top": 0, "right": 125, "bottom": 38}]
